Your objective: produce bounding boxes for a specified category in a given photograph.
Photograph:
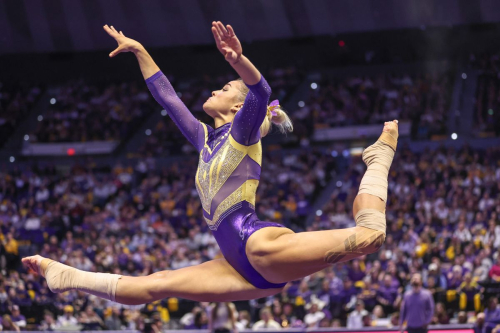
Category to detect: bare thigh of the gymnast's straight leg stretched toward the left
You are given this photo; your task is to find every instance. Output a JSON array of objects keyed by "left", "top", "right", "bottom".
[{"left": 143, "top": 258, "right": 282, "bottom": 302}]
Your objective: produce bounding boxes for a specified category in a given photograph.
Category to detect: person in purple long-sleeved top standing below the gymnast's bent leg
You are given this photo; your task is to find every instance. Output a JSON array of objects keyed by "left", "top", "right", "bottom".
[{"left": 399, "top": 273, "right": 434, "bottom": 333}]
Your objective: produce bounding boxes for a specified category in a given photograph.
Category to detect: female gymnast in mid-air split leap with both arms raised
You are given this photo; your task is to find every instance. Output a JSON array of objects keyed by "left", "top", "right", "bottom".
[{"left": 22, "top": 22, "right": 398, "bottom": 305}]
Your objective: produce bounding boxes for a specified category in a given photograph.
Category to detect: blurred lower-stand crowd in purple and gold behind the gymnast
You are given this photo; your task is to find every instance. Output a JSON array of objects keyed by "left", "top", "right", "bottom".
[{"left": 0, "top": 143, "right": 500, "bottom": 333}]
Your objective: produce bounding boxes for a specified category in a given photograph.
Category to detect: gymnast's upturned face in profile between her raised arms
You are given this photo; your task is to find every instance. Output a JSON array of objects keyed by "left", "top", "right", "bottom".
[{"left": 203, "top": 81, "right": 244, "bottom": 118}]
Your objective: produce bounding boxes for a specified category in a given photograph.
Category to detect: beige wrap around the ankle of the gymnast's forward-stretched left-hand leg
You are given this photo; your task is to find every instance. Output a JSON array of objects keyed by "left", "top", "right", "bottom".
[{"left": 45, "top": 261, "right": 122, "bottom": 301}]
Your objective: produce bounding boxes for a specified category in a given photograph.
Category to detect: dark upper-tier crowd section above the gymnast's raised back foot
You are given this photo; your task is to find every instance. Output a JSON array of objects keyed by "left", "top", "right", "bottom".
[{"left": 293, "top": 72, "right": 452, "bottom": 139}]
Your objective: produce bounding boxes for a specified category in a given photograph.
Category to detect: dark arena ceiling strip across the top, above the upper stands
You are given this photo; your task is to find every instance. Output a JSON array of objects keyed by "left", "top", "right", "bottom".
[{"left": 0, "top": 0, "right": 500, "bottom": 54}]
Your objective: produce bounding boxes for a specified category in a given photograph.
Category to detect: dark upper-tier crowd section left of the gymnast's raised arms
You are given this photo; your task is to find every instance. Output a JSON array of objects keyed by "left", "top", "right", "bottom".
[{"left": 30, "top": 80, "right": 155, "bottom": 143}]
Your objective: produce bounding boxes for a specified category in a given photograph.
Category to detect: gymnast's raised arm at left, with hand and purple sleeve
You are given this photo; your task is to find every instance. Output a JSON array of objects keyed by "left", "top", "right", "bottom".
[{"left": 104, "top": 25, "right": 205, "bottom": 151}]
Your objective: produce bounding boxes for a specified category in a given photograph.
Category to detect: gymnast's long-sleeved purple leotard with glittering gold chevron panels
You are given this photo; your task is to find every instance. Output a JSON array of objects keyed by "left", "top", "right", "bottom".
[{"left": 146, "top": 71, "right": 285, "bottom": 289}]
